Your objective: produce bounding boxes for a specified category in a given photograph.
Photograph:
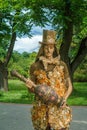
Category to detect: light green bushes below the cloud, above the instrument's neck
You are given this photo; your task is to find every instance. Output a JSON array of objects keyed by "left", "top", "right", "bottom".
[{"left": 8, "top": 51, "right": 36, "bottom": 78}]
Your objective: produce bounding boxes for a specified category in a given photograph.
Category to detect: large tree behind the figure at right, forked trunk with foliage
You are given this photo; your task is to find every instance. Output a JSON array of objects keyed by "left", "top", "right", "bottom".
[{"left": 26, "top": 0, "right": 87, "bottom": 78}]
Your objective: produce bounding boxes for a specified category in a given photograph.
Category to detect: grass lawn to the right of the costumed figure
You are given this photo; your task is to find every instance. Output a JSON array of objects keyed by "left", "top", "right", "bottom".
[{"left": 68, "top": 82, "right": 87, "bottom": 106}]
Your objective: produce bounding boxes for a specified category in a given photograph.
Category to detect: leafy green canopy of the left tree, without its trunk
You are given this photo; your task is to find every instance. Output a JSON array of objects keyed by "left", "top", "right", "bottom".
[{"left": 0, "top": 0, "right": 42, "bottom": 61}]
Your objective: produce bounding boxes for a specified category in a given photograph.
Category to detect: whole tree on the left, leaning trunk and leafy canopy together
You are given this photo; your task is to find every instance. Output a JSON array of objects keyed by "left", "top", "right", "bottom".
[{"left": 0, "top": 0, "right": 48, "bottom": 91}]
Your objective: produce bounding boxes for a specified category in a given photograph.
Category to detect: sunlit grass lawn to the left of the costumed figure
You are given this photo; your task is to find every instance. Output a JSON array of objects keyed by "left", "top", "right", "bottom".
[{"left": 0, "top": 80, "right": 34, "bottom": 104}]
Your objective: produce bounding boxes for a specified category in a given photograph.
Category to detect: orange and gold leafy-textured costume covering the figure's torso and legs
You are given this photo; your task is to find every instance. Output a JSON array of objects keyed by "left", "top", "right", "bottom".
[{"left": 30, "top": 58, "right": 72, "bottom": 130}]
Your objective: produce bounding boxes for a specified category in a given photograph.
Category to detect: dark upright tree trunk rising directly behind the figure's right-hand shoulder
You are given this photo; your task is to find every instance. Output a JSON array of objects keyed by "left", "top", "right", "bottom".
[{"left": 59, "top": 0, "right": 73, "bottom": 79}]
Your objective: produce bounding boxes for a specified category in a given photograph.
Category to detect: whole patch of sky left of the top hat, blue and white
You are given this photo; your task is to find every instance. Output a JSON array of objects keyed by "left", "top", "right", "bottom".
[{"left": 14, "top": 26, "right": 51, "bottom": 53}]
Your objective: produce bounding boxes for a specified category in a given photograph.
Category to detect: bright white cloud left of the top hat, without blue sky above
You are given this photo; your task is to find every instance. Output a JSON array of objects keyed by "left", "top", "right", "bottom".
[{"left": 14, "top": 35, "right": 42, "bottom": 53}]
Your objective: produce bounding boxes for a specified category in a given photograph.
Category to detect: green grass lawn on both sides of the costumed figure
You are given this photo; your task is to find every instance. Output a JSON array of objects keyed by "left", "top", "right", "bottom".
[{"left": 0, "top": 80, "right": 87, "bottom": 105}]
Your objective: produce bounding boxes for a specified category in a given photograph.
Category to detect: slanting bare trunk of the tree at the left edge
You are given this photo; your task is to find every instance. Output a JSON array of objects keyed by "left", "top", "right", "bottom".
[{"left": 0, "top": 32, "right": 16, "bottom": 91}]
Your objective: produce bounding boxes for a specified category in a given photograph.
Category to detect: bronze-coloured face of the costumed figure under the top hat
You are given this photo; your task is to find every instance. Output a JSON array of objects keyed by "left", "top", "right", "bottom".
[{"left": 44, "top": 44, "right": 54, "bottom": 58}]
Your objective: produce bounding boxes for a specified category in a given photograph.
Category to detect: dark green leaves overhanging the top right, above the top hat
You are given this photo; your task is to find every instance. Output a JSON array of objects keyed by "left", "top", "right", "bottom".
[{"left": 28, "top": 0, "right": 87, "bottom": 35}]
